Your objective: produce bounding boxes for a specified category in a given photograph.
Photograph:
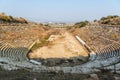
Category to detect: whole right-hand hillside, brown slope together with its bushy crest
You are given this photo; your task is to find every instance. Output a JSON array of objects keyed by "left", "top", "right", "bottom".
[{"left": 69, "top": 16, "right": 120, "bottom": 50}]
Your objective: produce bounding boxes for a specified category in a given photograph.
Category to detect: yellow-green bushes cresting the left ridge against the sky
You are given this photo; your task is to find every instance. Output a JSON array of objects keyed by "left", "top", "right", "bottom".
[{"left": 0, "top": 12, "right": 28, "bottom": 23}]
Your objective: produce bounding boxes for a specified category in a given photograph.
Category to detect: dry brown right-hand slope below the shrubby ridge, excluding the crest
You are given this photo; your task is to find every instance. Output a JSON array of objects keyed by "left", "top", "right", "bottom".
[{"left": 70, "top": 26, "right": 120, "bottom": 50}]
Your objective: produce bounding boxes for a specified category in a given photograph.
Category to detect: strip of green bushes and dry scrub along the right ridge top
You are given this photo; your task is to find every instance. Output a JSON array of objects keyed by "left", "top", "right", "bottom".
[{"left": 71, "top": 15, "right": 120, "bottom": 30}]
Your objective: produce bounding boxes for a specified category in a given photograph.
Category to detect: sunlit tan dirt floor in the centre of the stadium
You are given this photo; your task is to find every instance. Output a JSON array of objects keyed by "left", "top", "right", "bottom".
[{"left": 30, "top": 30, "right": 88, "bottom": 60}]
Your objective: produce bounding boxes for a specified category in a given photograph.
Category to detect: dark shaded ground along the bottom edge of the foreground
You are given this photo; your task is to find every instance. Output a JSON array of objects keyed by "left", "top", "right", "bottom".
[{"left": 0, "top": 69, "right": 120, "bottom": 80}]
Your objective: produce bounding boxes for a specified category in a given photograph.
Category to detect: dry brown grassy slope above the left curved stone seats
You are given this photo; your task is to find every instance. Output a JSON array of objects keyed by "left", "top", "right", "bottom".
[{"left": 0, "top": 24, "right": 46, "bottom": 47}]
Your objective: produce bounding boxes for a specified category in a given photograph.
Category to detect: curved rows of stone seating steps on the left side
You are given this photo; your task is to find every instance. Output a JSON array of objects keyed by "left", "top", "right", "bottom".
[{"left": 0, "top": 41, "right": 29, "bottom": 61}]
